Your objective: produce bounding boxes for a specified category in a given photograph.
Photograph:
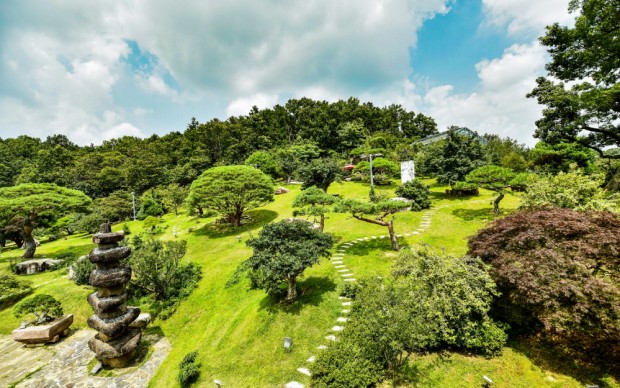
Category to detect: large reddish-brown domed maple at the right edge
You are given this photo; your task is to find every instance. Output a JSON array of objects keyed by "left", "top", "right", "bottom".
[{"left": 469, "top": 209, "right": 620, "bottom": 355}]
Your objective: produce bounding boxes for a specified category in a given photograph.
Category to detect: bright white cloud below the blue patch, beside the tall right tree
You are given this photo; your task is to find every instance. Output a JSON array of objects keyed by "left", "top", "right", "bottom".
[{"left": 423, "top": 43, "right": 546, "bottom": 145}]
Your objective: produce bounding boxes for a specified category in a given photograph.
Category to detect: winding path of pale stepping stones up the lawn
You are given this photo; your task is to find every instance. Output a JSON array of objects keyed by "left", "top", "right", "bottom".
[{"left": 285, "top": 206, "right": 448, "bottom": 388}]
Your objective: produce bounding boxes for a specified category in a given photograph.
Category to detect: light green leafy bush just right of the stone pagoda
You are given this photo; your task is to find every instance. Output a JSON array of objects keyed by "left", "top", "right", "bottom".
[{"left": 129, "top": 239, "right": 187, "bottom": 300}]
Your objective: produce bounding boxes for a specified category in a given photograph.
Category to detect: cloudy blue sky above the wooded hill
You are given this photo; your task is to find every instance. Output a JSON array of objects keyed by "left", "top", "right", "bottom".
[{"left": 0, "top": 0, "right": 575, "bottom": 145}]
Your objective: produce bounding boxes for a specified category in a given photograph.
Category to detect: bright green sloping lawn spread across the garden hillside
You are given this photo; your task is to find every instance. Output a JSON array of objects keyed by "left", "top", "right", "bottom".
[{"left": 0, "top": 182, "right": 614, "bottom": 387}]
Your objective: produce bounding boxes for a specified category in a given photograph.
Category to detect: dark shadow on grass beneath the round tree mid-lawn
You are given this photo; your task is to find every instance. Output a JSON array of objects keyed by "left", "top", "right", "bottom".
[{"left": 260, "top": 276, "right": 336, "bottom": 315}]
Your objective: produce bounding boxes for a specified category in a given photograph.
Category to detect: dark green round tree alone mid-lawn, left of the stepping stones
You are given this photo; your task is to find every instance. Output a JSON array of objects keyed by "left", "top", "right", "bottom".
[{"left": 240, "top": 220, "right": 334, "bottom": 302}]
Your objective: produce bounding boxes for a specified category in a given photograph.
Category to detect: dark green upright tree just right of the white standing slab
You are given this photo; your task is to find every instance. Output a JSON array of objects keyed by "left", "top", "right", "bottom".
[{"left": 434, "top": 128, "right": 485, "bottom": 185}]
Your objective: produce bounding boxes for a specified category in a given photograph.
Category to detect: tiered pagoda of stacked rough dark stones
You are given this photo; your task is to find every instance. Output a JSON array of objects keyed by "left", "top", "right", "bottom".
[{"left": 87, "top": 223, "right": 142, "bottom": 368}]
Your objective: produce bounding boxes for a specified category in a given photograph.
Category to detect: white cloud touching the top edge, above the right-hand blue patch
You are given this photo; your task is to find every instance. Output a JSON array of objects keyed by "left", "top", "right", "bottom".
[{"left": 483, "top": 0, "right": 575, "bottom": 36}]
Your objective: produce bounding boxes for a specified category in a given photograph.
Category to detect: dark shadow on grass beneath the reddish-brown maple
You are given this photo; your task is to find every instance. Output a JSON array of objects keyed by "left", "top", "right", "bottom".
[{"left": 508, "top": 338, "right": 620, "bottom": 387}]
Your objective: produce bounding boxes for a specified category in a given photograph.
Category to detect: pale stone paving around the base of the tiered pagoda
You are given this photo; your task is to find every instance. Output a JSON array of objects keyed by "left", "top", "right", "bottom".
[{"left": 0, "top": 330, "right": 171, "bottom": 388}]
